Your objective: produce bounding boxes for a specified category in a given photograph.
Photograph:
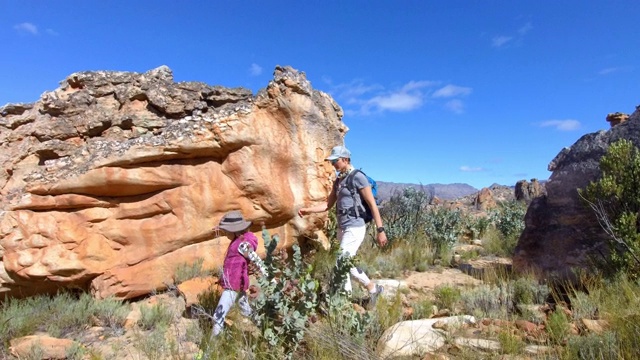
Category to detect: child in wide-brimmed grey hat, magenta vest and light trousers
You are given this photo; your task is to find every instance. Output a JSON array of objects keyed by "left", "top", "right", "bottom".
[{"left": 213, "top": 211, "right": 264, "bottom": 336}]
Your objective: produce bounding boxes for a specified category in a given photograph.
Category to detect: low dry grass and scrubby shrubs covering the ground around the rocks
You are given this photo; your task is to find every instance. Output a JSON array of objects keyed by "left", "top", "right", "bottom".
[{"left": 0, "top": 176, "right": 640, "bottom": 360}]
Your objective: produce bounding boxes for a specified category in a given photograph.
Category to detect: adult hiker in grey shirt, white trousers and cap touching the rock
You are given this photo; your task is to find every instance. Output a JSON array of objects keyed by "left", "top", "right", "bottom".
[{"left": 298, "top": 146, "right": 387, "bottom": 305}]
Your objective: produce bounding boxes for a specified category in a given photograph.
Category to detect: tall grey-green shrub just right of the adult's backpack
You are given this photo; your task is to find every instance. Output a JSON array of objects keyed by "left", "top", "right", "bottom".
[{"left": 380, "top": 187, "right": 433, "bottom": 245}]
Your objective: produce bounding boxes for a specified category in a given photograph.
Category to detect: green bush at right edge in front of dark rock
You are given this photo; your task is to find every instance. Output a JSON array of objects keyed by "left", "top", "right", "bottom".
[{"left": 578, "top": 139, "right": 640, "bottom": 278}]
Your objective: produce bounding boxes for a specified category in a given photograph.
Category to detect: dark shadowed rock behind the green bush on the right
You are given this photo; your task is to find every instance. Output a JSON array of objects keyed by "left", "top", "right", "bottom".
[{"left": 513, "top": 105, "right": 640, "bottom": 280}]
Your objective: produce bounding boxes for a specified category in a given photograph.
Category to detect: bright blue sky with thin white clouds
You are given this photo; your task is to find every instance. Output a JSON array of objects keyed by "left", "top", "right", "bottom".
[{"left": 0, "top": 0, "right": 640, "bottom": 189}]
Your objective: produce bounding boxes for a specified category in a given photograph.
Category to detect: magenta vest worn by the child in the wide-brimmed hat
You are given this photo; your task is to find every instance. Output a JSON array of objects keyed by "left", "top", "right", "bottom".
[{"left": 222, "top": 232, "right": 258, "bottom": 291}]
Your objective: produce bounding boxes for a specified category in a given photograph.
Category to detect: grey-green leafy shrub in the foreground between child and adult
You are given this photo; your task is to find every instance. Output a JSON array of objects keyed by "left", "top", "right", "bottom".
[{"left": 255, "top": 229, "right": 318, "bottom": 358}]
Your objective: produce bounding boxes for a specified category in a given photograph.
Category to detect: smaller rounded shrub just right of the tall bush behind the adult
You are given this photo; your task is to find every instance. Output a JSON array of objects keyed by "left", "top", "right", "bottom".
[{"left": 424, "top": 207, "right": 465, "bottom": 258}]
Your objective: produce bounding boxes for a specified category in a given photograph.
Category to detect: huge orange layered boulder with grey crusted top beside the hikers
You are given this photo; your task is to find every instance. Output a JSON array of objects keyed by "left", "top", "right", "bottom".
[{"left": 0, "top": 66, "right": 348, "bottom": 298}]
